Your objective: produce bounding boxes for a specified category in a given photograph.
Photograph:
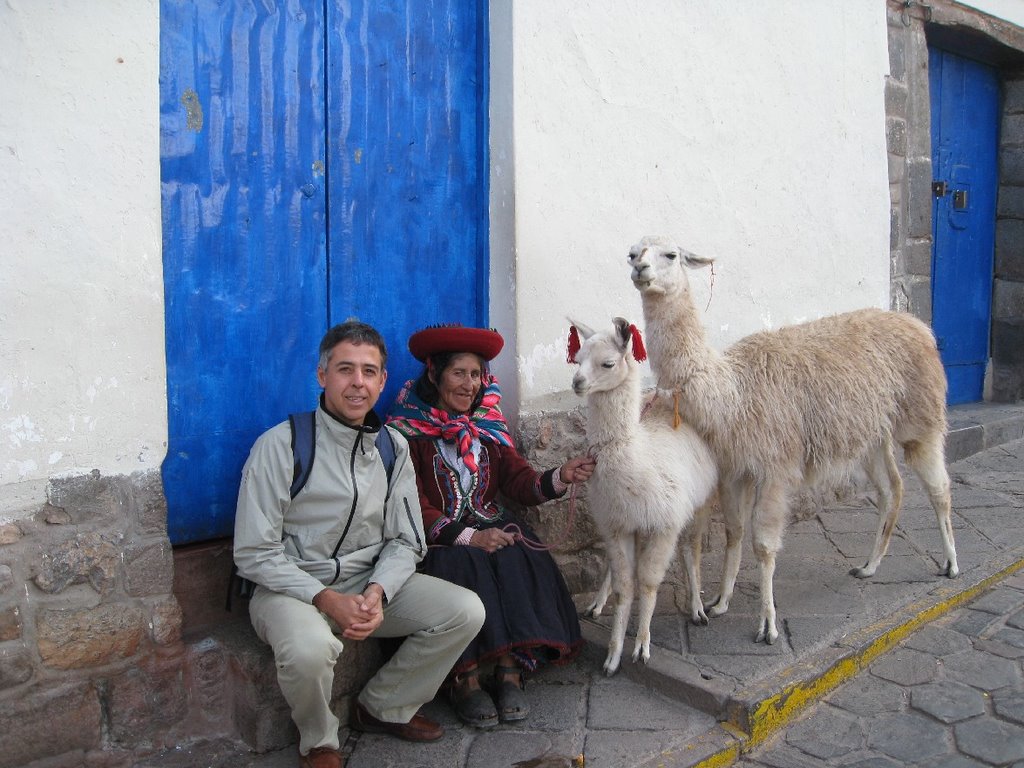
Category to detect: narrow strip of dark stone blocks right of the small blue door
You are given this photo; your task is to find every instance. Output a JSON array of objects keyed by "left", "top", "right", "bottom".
[{"left": 991, "top": 74, "right": 1024, "bottom": 402}]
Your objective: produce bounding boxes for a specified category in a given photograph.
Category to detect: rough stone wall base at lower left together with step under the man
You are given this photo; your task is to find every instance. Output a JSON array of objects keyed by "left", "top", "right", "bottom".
[{"left": 0, "top": 471, "right": 448, "bottom": 768}]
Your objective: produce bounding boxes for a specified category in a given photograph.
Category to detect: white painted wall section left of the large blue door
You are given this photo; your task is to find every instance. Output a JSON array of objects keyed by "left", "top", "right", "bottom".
[{"left": 0, "top": 0, "right": 167, "bottom": 520}]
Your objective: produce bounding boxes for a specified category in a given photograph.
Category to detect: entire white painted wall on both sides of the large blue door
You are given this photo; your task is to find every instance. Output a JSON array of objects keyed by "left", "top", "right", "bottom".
[{"left": 0, "top": 0, "right": 1011, "bottom": 519}]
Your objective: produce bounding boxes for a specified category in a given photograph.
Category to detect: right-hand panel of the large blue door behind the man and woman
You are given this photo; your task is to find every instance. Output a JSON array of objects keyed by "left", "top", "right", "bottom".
[{"left": 328, "top": 0, "right": 487, "bottom": 408}]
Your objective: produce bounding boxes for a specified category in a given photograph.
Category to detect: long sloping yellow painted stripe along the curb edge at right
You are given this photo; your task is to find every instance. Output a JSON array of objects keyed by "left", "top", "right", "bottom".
[{"left": 729, "top": 560, "right": 1024, "bottom": 753}]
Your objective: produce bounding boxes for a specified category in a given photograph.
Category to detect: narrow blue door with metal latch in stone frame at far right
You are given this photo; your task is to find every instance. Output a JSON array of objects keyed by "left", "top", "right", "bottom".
[{"left": 929, "top": 49, "right": 999, "bottom": 404}]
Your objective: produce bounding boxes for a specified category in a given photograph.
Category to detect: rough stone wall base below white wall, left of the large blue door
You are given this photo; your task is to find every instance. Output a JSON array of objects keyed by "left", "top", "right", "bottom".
[{"left": 0, "top": 471, "right": 188, "bottom": 768}]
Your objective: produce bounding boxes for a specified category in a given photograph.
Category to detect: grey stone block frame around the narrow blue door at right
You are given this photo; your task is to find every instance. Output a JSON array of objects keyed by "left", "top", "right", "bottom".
[{"left": 886, "top": 0, "right": 1024, "bottom": 402}]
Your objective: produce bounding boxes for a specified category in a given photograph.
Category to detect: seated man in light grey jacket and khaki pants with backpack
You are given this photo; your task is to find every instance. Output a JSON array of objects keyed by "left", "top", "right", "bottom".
[{"left": 234, "top": 321, "right": 484, "bottom": 768}]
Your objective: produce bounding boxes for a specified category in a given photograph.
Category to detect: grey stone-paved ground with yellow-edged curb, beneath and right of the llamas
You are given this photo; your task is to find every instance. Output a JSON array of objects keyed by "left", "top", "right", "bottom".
[{"left": 136, "top": 407, "right": 1024, "bottom": 768}]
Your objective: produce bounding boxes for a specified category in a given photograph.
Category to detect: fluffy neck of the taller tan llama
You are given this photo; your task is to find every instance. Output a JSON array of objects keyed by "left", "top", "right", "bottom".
[{"left": 643, "top": 294, "right": 739, "bottom": 442}]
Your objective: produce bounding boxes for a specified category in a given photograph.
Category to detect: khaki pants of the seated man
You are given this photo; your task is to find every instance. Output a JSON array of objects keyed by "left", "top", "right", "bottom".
[{"left": 249, "top": 573, "right": 484, "bottom": 755}]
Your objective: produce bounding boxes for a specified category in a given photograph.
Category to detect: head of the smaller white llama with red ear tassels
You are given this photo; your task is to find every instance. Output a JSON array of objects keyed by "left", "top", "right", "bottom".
[{"left": 569, "top": 317, "right": 647, "bottom": 397}]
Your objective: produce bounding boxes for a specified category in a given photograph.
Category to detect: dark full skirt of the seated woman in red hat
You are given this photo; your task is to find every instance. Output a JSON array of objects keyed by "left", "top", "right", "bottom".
[{"left": 420, "top": 521, "right": 583, "bottom": 674}]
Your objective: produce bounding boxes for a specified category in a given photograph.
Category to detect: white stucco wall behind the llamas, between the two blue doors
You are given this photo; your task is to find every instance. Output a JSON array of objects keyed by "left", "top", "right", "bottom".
[{"left": 513, "top": 0, "right": 890, "bottom": 411}]
